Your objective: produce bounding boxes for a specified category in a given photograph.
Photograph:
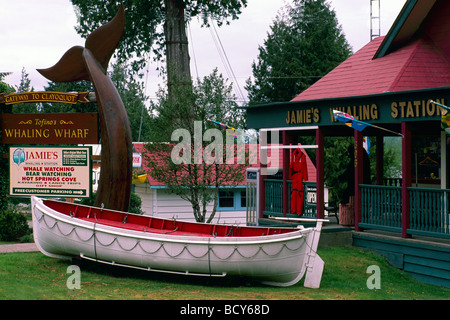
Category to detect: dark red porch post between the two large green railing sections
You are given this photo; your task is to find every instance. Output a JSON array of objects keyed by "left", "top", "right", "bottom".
[{"left": 402, "top": 122, "right": 412, "bottom": 238}]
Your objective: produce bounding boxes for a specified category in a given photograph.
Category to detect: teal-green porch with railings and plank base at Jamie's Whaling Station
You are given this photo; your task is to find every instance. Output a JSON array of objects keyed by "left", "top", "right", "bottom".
[{"left": 261, "top": 179, "right": 450, "bottom": 288}]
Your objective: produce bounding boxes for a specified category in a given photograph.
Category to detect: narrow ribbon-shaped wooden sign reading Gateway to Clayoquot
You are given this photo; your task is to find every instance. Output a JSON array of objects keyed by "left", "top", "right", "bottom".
[{"left": 0, "top": 91, "right": 91, "bottom": 105}]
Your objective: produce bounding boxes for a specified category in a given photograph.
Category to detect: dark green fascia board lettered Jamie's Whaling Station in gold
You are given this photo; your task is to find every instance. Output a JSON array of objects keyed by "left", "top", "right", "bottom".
[{"left": 246, "top": 86, "right": 450, "bottom": 134}]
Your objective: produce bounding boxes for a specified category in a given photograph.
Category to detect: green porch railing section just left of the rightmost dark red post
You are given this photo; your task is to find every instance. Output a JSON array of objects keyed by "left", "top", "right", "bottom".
[{"left": 359, "top": 184, "right": 402, "bottom": 232}]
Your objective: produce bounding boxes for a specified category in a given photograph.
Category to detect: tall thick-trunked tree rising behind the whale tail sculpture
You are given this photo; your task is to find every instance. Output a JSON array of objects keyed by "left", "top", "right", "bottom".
[{"left": 72, "top": 0, "right": 247, "bottom": 221}]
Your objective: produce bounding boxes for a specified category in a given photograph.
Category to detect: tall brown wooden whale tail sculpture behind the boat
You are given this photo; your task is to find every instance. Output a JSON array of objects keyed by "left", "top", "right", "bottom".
[{"left": 38, "top": 5, "right": 132, "bottom": 211}]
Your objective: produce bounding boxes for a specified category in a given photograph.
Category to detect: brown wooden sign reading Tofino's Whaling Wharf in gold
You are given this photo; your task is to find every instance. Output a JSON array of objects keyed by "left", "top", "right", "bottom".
[{"left": 0, "top": 113, "right": 98, "bottom": 145}]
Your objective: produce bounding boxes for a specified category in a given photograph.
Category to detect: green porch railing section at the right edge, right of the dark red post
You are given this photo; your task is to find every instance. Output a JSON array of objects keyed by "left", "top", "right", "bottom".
[{"left": 408, "top": 188, "right": 450, "bottom": 238}]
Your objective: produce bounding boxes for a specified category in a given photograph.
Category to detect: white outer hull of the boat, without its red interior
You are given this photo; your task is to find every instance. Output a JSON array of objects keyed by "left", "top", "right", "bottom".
[{"left": 32, "top": 197, "right": 320, "bottom": 286}]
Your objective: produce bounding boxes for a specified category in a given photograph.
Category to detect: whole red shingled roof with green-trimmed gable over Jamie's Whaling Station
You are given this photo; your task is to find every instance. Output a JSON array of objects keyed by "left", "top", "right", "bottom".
[{"left": 292, "top": 0, "right": 450, "bottom": 101}]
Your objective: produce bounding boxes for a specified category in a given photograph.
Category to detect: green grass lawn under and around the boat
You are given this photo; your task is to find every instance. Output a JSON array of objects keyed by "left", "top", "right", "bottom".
[{"left": 0, "top": 247, "right": 450, "bottom": 300}]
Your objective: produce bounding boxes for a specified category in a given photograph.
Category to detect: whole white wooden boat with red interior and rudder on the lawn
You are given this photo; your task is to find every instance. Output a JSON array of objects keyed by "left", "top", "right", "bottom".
[{"left": 32, "top": 197, "right": 324, "bottom": 288}]
